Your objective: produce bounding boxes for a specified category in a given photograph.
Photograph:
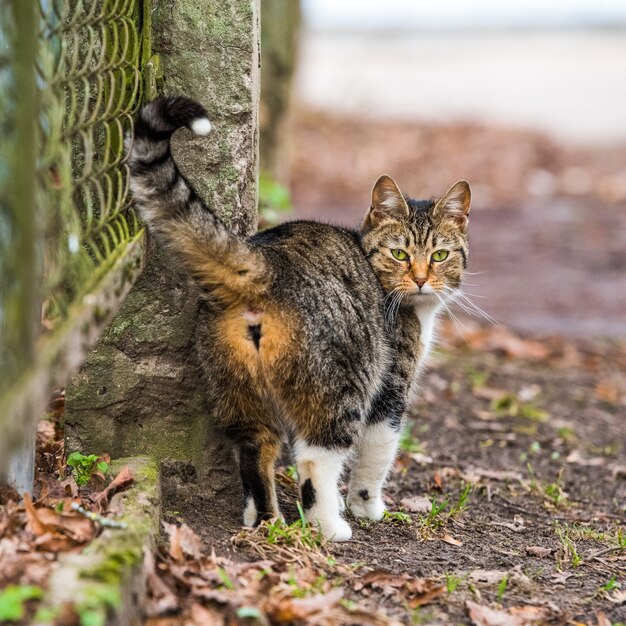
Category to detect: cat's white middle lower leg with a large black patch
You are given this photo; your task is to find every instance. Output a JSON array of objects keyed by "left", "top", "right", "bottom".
[{"left": 294, "top": 441, "right": 352, "bottom": 541}]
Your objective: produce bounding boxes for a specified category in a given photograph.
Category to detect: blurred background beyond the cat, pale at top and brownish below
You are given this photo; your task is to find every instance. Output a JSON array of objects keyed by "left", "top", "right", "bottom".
[{"left": 261, "top": 0, "right": 626, "bottom": 338}]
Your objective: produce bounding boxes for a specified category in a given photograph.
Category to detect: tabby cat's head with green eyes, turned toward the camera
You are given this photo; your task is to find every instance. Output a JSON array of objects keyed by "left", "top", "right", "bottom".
[{"left": 361, "top": 176, "right": 471, "bottom": 305}]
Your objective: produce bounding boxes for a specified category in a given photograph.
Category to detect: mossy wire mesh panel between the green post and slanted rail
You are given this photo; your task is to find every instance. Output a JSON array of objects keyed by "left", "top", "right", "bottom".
[{"left": 38, "top": 0, "right": 142, "bottom": 324}]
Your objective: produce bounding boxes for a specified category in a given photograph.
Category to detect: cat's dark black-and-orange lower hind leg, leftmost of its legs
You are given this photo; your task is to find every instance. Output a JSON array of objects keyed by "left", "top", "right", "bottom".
[{"left": 238, "top": 434, "right": 281, "bottom": 526}]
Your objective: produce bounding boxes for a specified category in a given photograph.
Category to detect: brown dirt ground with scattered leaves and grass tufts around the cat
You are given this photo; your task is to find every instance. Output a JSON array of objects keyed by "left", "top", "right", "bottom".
[{"left": 161, "top": 326, "right": 626, "bottom": 626}]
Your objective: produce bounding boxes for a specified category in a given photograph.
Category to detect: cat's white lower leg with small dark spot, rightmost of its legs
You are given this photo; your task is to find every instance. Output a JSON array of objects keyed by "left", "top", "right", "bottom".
[{"left": 348, "top": 421, "right": 400, "bottom": 520}]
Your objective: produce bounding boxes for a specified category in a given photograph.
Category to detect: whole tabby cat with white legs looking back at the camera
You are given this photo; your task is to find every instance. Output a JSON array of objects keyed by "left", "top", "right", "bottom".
[{"left": 128, "top": 98, "right": 470, "bottom": 540}]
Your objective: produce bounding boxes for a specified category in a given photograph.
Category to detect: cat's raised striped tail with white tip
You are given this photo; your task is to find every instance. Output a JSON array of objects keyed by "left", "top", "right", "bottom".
[{"left": 127, "top": 96, "right": 270, "bottom": 300}]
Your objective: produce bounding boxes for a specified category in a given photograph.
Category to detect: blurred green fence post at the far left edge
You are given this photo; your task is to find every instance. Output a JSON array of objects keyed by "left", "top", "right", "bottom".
[{"left": 0, "top": 0, "right": 41, "bottom": 491}]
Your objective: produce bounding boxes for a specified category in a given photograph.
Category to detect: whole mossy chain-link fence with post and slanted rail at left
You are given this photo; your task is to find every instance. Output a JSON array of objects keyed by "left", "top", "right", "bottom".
[{"left": 0, "top": 0, "right": 158, "bottom": 488}]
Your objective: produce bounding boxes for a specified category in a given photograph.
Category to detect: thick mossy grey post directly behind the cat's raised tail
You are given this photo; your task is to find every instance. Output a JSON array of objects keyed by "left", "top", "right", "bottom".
[{"left": 65, "top": 0, "right": 260, "bottom": 528}]
